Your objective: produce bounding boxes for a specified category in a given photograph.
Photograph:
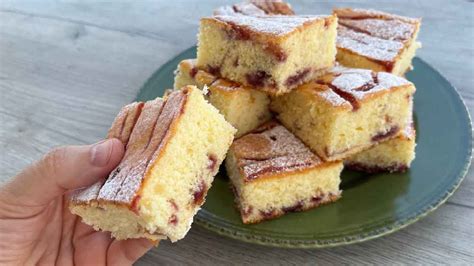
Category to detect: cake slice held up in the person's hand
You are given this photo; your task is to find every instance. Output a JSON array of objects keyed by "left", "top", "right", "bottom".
[{"left": 70, "top": 86, "right": 235, "bottom": 242}]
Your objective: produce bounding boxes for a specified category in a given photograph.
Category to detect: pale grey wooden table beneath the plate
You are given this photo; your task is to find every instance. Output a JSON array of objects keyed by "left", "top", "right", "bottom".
[{"left": 0, "top": 0, "right": 474, "bottom": 265}]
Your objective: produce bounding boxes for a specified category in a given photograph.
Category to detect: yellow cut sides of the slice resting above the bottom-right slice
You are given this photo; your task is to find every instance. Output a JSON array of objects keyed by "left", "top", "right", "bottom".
[{"left": 271, "top": 69, "right": 415, "bottom": 160}]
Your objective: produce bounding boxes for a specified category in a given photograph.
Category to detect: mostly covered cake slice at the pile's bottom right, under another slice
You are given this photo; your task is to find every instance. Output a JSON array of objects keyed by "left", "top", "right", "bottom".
[{"left": 344, "top": 124, "right": 416, "bottom": 173}]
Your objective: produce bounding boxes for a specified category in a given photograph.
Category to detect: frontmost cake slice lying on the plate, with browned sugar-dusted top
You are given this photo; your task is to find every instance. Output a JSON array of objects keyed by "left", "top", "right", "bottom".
[{"left": 226, "top": 121, "right": 343, "bottom": 224}]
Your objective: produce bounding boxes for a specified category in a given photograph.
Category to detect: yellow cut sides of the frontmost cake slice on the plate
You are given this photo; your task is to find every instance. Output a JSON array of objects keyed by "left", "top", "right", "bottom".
[{"left": 225, "top": 149, "right": 343, "bottom": 223}]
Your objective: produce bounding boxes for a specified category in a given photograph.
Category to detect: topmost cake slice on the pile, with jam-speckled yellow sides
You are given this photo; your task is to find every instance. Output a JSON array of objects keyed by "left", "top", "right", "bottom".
[{"left": 197, "top": 16, "right": 337, "bottom": 95}]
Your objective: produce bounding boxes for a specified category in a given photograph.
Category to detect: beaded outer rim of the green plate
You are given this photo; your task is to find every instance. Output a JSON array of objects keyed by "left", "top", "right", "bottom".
[{"left": 135, "top": 45, "right": 473, "bottom": 249}]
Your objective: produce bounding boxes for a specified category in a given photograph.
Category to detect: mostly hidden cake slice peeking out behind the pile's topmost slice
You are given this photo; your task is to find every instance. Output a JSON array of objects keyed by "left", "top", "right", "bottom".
[{"left": 214, "top": 0, "right": 295, "bottom": 16}]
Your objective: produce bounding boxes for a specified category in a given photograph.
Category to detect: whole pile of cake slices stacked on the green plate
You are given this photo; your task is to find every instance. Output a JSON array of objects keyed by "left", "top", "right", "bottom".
[{"left": 174, "top": 0, "right": 420, "bottom": 223}]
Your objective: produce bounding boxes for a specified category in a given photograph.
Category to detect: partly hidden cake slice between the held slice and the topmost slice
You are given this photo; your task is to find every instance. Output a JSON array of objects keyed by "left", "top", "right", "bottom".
[{"left": 174, "top": 59, "right": 271, "bottom": 137}]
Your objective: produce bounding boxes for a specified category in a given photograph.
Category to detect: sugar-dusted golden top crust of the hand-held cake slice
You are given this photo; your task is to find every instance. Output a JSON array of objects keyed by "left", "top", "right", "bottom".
[{"left": 71, "top": 90, "right": 187, "bottom": 209}]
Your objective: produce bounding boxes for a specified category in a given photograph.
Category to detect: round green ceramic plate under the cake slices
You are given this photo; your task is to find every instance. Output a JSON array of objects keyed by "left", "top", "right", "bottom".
[{"left": 138, "top": 47, "right": 472, "bottom": 248}]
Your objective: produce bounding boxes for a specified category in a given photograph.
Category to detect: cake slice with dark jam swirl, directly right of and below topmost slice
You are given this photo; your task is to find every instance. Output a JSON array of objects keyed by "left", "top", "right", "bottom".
[{"left": 271, "top": 67, "right": 415, "bottom": 160}]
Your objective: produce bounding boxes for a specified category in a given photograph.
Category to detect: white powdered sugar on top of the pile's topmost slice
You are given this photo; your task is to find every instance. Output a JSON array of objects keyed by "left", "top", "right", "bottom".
[{"left": 214, "top": 15, "right": 328, "bottom": 35}]
